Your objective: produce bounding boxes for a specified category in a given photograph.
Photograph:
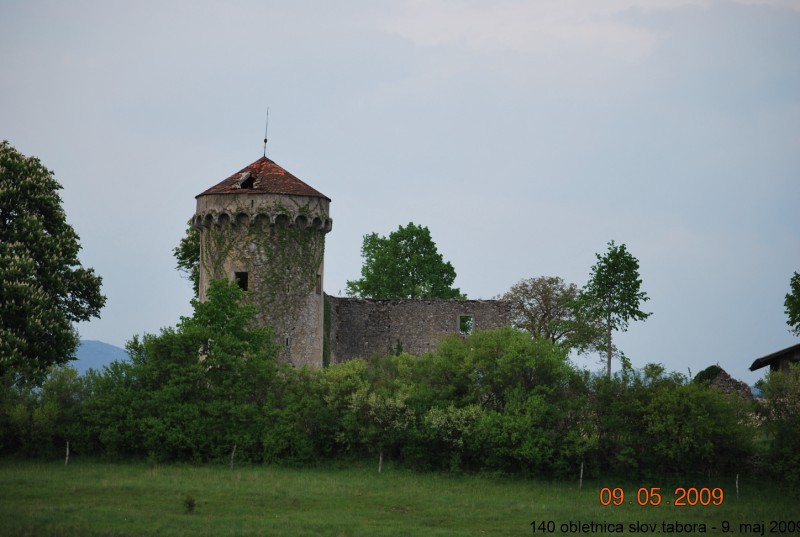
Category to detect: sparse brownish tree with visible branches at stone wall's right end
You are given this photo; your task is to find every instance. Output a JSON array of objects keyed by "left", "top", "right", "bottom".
[{"left": 501, "top": 276, "right": 600, "bottom": 350}]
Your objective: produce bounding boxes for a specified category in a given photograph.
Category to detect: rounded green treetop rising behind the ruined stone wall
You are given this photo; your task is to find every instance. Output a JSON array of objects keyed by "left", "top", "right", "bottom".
[{"left": 347, "top": 222, "right": 464, "bottom": 299}]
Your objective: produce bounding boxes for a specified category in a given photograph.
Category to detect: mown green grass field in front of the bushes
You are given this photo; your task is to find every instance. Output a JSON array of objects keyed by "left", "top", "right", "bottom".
[{"left": 0, "top": 460, "right": 800, "bottom": 537}]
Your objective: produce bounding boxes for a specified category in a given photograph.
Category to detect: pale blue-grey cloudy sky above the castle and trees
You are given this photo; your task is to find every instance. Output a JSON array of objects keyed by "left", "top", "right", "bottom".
[{"left": 0, "top": 0, "right": 800, "bottom": 384}]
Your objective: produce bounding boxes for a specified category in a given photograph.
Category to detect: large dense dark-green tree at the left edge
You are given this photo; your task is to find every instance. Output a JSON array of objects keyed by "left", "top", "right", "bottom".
[{"left": 0, "top": 141, "right": 106, "bottom": 382}]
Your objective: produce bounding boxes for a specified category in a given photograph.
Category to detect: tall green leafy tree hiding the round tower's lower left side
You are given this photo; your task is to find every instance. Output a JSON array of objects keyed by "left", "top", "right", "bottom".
[{"left": 142, "top": 279, "right": 277, "bottom": 460}]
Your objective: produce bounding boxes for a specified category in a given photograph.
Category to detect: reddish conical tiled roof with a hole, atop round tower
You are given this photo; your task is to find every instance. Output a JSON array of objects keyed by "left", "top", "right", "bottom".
[{"left": 195, "top": 157, "right": 331, "bottom": 201}]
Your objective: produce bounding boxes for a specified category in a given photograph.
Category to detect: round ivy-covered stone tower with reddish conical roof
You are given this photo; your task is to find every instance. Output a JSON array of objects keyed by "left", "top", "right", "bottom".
[{"left": 193, "top": 157, "right": 332, "bottom": 367}]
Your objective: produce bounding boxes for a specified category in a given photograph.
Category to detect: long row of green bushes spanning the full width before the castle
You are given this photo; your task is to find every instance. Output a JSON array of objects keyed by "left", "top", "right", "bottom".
[{"left": 0, "top": 282, "right": 800, "bottom": 481}]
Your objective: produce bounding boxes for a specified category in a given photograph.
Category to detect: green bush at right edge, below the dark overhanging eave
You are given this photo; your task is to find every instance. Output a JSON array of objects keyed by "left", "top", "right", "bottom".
[{"left": 757, "top": 364, "right": 800, "bottom": 486}]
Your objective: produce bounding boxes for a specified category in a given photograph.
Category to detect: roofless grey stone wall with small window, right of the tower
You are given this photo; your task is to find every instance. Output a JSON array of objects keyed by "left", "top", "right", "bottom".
[{"left": 327, "top": 296, "right": 511, "bottom": 363}]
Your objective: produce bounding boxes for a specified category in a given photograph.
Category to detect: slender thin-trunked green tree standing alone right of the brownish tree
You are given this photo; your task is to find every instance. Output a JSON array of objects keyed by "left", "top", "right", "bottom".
[{"left": 580, "top": 241, "right": 652, "bottom": 376}]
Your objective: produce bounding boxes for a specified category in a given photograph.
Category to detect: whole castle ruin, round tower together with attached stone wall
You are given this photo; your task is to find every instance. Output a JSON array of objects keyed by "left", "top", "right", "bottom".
[{"left": 192, "top": 157, "right": 510, "bottom": 367}]
